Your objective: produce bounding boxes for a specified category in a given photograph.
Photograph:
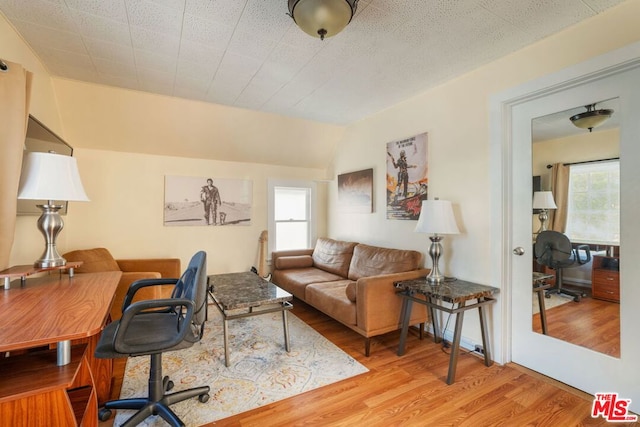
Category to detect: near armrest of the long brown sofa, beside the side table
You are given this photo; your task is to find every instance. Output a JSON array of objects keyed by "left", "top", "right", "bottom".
[{"left": 356, "top": 269, "right": 430, "bottom": 337}]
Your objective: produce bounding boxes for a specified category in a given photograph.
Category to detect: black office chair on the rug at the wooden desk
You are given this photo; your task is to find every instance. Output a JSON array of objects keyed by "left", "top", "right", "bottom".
[{"left": 95, "top": 251, "right": 209, "bottom": 426}]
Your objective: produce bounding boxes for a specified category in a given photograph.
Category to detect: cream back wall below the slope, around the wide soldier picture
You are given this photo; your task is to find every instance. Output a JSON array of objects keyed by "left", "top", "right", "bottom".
[{"left": 11, "top": 149, "right": 326, "bottom": 273}]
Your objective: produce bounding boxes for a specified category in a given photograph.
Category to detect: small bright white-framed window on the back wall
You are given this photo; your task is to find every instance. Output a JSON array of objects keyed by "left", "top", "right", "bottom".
[{"left": 269, "top": 180, "right": 316, "bottom": 252}]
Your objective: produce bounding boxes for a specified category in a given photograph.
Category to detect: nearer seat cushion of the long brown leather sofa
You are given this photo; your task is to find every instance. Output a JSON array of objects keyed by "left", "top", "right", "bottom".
[{"left": 305, "top": 280, "right": 356, "bottom": 325}]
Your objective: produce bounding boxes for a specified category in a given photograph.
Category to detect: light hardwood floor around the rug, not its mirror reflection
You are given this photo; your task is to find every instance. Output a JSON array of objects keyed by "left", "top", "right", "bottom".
[{"left": 100, "top": 300, "right": 625, "bottom": 427}]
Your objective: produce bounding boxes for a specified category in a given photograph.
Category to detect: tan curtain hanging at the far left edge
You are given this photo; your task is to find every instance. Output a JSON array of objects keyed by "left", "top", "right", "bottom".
[{"left": 0, "top": 60, "right": 32, "bottom": 270}]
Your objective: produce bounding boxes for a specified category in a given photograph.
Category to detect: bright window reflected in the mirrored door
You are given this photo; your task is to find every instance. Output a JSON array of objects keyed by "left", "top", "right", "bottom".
[{"left": 566, "top": 160, "right": 620, "bottom": 245}]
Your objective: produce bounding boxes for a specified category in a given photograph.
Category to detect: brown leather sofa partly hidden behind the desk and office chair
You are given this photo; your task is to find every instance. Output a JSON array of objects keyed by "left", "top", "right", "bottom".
[{"left": 62, "top": 248, "right": 182, "bottom": 320}]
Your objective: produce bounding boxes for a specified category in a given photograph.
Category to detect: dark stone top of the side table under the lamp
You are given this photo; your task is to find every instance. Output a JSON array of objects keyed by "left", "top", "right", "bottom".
[{"left": 394, "top": 278, "right": 500, "bottom": 303}]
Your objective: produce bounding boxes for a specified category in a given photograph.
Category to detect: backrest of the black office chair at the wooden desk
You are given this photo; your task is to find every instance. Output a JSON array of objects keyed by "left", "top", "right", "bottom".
[{"left": 171, "top": 251, "right": 207, "bottom": 342}]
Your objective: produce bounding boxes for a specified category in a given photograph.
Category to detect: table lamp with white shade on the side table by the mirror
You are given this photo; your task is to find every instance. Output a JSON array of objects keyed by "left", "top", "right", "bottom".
[{"left": 414, "top": 198, "right": 460, "bottom": 285}]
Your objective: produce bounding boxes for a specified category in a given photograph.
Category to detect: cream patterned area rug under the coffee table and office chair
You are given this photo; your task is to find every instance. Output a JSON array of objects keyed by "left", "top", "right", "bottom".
[{"left": 114, "top": 307, "right": 368, "bottom": 426}]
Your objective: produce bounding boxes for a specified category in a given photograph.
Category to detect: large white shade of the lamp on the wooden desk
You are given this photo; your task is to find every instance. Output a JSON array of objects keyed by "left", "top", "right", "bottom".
[{"left": 18, "top": 152, "right": 89, "bottom": 202}]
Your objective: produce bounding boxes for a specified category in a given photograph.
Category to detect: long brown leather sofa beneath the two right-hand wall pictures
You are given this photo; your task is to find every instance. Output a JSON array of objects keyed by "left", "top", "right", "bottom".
[{"left": 271, "top": 238, "right": 429, "bottom": 356}]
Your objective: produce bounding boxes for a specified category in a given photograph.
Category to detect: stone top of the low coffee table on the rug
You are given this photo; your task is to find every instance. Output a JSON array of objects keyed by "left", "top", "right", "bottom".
[{"left": 209, "top": 271, "right": 293, "bottom": 310}]
